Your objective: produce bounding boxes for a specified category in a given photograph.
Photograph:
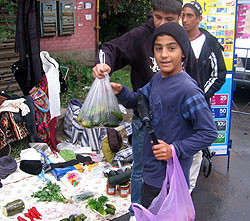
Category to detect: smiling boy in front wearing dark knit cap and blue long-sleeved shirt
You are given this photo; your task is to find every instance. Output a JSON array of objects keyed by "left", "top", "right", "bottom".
[{"left": 111, "top": 22, "right": 217, "bottom": 209}]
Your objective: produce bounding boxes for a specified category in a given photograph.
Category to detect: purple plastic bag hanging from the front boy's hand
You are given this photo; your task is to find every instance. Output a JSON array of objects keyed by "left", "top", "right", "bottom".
[{"left": 132, "top": 148, "right": 195, "bottom": 221}]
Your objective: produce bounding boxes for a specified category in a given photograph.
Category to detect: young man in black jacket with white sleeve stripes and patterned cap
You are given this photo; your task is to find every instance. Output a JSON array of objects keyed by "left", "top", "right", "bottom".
[{"left": 182, "top": 1, "right": 227, "bottom": 192}]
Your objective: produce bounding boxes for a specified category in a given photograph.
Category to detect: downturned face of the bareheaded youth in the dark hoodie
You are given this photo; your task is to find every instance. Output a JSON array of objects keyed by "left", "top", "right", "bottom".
[{"left": 153, "top": 11, "right": 180, "bottom": 28}]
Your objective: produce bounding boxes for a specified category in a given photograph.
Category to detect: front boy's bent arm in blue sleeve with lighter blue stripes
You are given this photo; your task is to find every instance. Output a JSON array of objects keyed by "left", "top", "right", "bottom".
[{"left": 173, "top": 89, "right": 217, "bottom": 158}]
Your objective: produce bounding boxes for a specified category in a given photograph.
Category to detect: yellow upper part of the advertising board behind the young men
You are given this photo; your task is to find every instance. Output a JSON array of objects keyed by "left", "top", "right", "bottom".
[{"left": 183, "top": 0, "right": 236, "bottom": 71}]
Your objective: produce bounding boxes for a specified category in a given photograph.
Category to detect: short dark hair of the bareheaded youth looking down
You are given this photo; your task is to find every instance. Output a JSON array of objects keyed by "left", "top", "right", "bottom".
[{"left": 152, "top": 0, "right": 182, "bottom": 16}]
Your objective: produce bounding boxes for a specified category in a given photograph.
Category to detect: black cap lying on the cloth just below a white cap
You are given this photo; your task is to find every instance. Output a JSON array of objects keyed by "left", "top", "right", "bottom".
[{"left": 20, "top": 160, "right": 42, "bottom": 175}]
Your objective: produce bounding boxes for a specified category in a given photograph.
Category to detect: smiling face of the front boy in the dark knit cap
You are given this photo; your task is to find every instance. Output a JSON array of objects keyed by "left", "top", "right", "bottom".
[{"left": 154, "top": 35, "right": 184, "bottom": 78}]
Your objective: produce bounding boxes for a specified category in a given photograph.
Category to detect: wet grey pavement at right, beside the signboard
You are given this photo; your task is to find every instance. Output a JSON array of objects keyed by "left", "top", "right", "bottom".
[{"left": 193, "top": 86, "right": 250, "bottom": 221}]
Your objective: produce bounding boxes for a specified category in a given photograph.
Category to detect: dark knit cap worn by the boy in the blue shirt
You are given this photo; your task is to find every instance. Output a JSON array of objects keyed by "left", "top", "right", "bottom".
[{"left": 152, "top": 22, "right": 190, "bottom": 58}]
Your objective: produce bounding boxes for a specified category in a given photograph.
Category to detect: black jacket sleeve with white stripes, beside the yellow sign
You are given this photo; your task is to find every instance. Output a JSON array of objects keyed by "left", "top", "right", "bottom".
[{"left": 204, "top": 43, "right": 227, "bottom": 100}]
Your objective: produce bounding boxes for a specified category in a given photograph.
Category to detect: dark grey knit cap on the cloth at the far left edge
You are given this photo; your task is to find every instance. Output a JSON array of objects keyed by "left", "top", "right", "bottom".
[{"left": 0, "top": 156, "right": 17, "bottom": 179}]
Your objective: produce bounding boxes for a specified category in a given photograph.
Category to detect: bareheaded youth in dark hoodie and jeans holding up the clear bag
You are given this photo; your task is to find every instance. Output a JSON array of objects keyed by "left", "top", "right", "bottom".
[{"left": 93, "top": 0, "right": 199, "bottom": 219}]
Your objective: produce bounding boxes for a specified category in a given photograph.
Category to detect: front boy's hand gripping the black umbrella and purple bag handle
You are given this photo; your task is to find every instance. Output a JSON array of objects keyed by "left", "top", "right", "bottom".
[{"left": 152, "top": 140, "right": 173, "bottom": 161}]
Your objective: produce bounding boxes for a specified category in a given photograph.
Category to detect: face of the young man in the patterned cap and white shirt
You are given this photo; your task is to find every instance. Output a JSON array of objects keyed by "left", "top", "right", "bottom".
[{"left": 182, "top": 7, "right": 202, "bottom": 32}]
